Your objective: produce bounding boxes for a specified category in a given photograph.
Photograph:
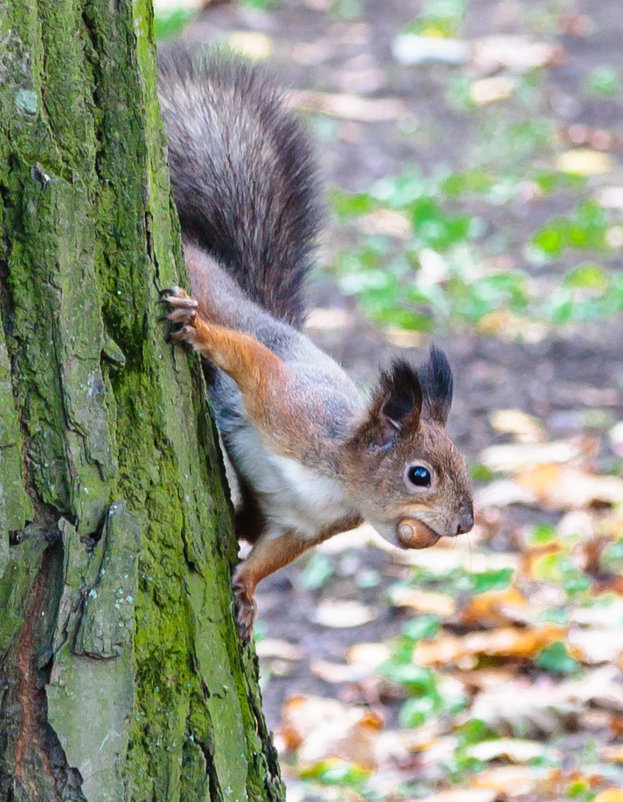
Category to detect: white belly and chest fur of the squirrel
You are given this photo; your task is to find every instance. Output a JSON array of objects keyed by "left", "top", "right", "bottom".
[{"left": 230, "top": 426, "right": 355, "bottom": 539}]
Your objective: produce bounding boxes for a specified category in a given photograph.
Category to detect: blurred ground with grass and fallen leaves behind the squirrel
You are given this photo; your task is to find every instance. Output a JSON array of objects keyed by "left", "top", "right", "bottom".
[{"left": 156, "top": 0, "right": 623, "bottom": 802}]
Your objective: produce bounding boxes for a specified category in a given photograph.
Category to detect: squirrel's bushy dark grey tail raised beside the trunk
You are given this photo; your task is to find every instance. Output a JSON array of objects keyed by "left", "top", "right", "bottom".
[{"left": 158, "top": 47, "right": 321, "bottom": 327}]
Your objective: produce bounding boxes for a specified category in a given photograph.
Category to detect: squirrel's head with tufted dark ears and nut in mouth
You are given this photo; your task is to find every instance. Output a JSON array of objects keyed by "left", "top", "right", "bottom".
[{"left": 344, "top": 347, "right": 474, "bottom": 548}]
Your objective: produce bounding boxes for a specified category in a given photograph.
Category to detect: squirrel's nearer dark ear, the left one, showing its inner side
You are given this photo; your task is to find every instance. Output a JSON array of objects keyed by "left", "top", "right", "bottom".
[{"left": 370, "top": 359, "right": 422, "bottom": 447}]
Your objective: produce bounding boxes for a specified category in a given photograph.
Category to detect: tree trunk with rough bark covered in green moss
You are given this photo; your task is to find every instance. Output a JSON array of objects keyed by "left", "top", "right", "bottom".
[{"left": 0, "top": 0, "right": 283, "bottom": 802}]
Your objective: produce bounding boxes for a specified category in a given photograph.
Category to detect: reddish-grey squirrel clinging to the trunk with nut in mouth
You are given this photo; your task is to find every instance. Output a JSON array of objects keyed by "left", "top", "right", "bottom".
[{"left": 158, "top": 46, "right": 474, "bottom": 640}]
